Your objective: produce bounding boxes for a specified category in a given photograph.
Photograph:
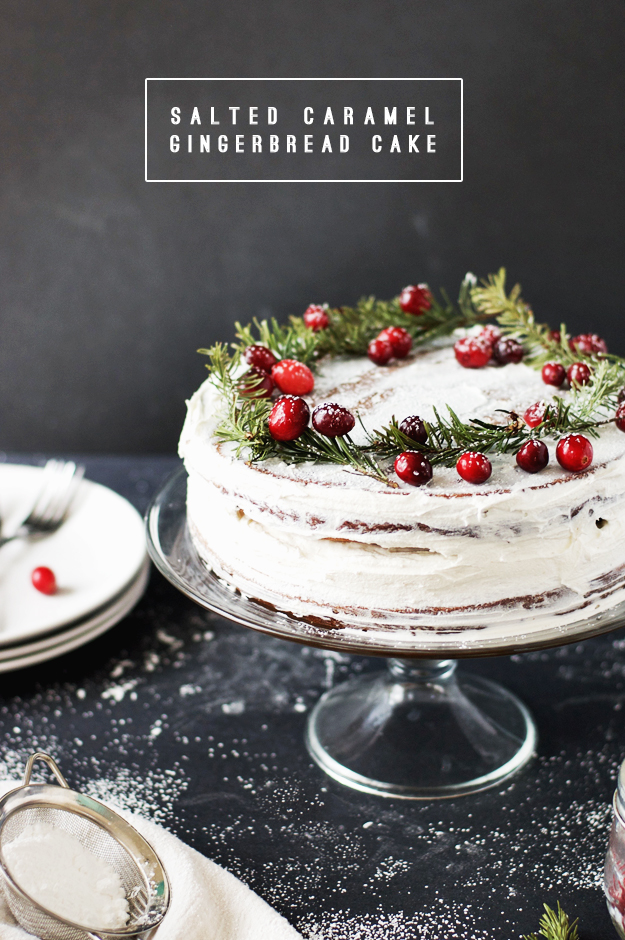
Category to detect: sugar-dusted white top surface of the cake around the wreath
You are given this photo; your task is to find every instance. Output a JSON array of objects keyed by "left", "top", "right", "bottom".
[{"left": 181, "top": 336, "right": 625, "bottom": 497}]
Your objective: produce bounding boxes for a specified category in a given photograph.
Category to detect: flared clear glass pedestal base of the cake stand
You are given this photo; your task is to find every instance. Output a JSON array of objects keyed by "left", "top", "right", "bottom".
[{"left": 306, "top": 659, "right": 536, "bottom": 800}]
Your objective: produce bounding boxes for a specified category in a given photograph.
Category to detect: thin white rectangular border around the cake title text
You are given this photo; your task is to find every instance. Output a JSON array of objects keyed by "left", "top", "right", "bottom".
[{"left": 144, "top": 77, "right": 464, "bottom": 183}]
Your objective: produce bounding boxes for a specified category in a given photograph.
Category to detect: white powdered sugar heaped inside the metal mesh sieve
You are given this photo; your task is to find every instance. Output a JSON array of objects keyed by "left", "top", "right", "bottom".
[{"left": 3, "top": 822, "right": 128, "bottom": 930}]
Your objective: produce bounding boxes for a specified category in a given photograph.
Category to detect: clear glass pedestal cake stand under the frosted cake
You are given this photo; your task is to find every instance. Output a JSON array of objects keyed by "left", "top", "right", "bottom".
[{"left": 146, "top": 468, "right": 625, "bottom": 799}]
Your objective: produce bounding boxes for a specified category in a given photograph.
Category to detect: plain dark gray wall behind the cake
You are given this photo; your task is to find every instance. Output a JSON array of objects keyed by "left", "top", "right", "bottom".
[{"left": 0, "top": 0, "right": 625, "bottom": 452}]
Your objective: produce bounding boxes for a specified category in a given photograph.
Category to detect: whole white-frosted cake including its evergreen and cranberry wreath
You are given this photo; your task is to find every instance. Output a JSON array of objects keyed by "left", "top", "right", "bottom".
[{"left": 180, "top": 269, "right": 625, "bottom": 647}]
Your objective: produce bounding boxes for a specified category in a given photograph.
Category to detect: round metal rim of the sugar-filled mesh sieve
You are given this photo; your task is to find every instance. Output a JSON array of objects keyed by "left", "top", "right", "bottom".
[{"left": 0, "top": 783, "right": 171, "bottom": 938}]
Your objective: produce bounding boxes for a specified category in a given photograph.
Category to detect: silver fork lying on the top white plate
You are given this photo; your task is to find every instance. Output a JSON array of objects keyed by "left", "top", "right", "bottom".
[{"left": 0, "top": 460, "right": 85, "bottom": 548}]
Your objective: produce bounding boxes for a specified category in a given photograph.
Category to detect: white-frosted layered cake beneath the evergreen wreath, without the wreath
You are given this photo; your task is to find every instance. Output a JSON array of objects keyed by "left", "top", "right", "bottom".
[{"left": 180, "top": 278, "right": 625, "bottom": 642}]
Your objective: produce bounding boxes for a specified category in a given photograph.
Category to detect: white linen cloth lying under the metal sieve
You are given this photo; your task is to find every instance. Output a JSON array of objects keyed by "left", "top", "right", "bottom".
[{"left": 0, "top": 780, "right": 302, "bottom": 940}]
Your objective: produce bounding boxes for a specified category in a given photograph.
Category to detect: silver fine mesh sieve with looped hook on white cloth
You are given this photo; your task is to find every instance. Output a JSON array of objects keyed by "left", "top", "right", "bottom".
[{"left": 0, "top": 753, "right": 170, "bottom": 940}]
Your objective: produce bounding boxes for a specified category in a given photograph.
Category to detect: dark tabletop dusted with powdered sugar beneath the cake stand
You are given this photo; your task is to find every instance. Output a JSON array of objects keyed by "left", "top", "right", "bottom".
[{"left": 0, "top": 457, "right": 625, "bottom": 940}]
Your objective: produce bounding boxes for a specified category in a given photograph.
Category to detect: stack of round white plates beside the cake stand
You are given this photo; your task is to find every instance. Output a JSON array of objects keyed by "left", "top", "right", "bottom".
[{"left": 0, "top": 464, "right": 149, "bottom": 672}]
